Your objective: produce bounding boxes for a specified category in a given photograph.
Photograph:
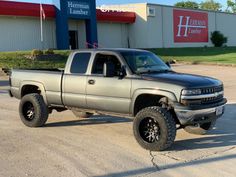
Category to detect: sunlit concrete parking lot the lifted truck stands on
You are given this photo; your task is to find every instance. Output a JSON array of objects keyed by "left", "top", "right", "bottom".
[{"left": 0, "top": 65, "right": 236, "bottom": 177}]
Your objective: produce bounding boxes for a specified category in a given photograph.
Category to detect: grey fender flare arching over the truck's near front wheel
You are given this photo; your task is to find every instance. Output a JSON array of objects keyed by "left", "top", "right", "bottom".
[{"left": 130, "top": 89, "right": 177, "bottom": 115}]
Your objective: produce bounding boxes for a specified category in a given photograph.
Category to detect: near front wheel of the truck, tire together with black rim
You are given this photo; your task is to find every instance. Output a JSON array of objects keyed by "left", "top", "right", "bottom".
[{"left": 133, "top": 106, "right": 176, "bottom": 151}]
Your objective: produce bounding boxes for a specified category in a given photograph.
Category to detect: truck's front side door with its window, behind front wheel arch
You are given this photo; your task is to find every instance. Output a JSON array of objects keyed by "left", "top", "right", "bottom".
[{"left": 87, "top": 52, "right": 131, "bottom": 114}]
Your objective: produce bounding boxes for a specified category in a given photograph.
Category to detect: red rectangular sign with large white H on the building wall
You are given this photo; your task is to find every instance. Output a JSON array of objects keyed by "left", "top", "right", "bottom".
[{"left": 173, "top": 9, "right": 208, "bottom": 42}]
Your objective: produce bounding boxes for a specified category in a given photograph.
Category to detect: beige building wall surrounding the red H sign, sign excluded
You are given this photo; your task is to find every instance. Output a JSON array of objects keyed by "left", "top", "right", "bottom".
[{"left": 124, "top": 3, "right": 236, "bottom": 48}]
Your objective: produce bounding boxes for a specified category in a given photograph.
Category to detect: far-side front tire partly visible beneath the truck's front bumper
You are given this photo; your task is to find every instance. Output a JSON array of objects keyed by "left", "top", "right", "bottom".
[{"left": 184, "top": 120, "right": 216, "bottom": 135}]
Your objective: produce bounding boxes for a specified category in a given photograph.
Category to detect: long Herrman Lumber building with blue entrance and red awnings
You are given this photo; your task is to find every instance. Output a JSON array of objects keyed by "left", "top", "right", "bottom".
[{"left": 0, "top": 0, "right": 236, "bottom": 51}]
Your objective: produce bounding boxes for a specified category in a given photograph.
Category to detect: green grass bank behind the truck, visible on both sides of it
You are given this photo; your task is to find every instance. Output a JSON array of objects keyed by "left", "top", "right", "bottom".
[{"left": 0, "top": 47, "right": 236, "bottom": 69}]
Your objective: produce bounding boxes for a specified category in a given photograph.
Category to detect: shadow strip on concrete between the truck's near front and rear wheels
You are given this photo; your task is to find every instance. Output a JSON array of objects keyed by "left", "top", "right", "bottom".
[{"left": 45, "top": 116, "right": 133, "bottom": 127}]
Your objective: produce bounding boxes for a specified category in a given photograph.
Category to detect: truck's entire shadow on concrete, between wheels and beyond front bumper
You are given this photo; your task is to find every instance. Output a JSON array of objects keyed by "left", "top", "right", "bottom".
[{"left": 45, "top": 104, "right": 236, "bottom": 152}]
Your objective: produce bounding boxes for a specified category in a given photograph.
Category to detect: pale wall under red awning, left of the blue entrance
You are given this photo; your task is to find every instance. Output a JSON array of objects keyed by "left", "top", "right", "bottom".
[{"left": 0, "top": 16, "right": 56, "bottom": 51}]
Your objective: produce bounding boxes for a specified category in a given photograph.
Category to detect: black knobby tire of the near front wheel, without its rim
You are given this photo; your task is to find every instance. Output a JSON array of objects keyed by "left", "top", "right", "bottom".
[{"left": 133, "top": 106, "right": 176, "bottom": 151}]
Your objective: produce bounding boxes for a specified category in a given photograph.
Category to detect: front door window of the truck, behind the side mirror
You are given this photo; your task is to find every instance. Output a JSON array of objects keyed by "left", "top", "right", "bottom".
[{"left": 92, "top": 54, "right": 121, "bottom": 76}]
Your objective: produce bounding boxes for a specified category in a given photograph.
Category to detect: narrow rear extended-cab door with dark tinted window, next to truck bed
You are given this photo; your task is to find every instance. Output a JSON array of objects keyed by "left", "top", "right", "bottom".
[{"left": 62, "top": 52, "right": 91, "bottom": 108}]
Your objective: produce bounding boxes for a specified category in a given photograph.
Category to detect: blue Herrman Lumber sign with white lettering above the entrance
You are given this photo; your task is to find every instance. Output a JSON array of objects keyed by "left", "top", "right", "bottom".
[{"left": 67, "top": 1, "right": 90, "bottom": 17}]
